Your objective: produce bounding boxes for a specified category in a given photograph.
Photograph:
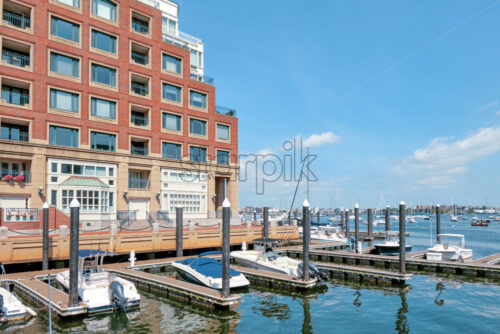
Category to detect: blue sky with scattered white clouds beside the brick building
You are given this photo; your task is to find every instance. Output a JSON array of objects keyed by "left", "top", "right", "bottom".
[{"left": 179, "top": 0, "right": 500, "bottom": 207}]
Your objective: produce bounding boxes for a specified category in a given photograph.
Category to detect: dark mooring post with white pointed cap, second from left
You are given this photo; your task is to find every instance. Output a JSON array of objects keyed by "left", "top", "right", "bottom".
[{"left": 69, "top": 198, "right": 80, "bottom": 306}]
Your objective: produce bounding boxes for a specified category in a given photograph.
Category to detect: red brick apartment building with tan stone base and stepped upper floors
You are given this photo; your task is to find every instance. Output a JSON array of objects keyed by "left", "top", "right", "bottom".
[{"left": 0, "top": 0, "right": 238, "bottom": 226}]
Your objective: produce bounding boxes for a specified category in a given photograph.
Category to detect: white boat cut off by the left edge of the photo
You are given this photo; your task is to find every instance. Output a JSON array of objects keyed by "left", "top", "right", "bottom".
[{"left": 0, "top": 263, "right": 36, "bottom": 324}]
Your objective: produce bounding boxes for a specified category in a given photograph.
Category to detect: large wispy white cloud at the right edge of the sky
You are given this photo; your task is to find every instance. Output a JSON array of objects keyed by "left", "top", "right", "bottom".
[{"left": 393, "top": 126, "right": 500, "bottom": 188}]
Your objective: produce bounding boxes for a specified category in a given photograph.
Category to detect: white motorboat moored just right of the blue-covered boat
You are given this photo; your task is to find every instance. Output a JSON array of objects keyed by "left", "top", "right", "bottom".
[{"left": 231, "top": 238, "right": 324, "bottom": 280}]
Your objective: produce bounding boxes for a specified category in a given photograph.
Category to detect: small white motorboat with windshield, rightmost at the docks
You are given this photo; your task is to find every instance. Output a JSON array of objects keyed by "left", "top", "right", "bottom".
[{"left": 425, "top": 234, "right": 472, "bottom": 262}]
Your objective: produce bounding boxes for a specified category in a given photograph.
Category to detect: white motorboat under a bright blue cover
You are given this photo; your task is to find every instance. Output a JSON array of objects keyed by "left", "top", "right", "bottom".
[{"left": 172, "top": 251, "right": 250, "bottom": 290}]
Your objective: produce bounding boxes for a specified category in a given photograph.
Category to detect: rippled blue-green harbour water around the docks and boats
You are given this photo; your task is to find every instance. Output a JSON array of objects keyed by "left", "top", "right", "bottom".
[{"left": 4, "top": 217, "right": 500, "bottom": 334}]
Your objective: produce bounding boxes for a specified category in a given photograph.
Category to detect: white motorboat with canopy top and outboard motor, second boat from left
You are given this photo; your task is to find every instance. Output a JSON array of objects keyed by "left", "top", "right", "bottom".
[{"left": 56, "top": 249, "right": 141, "bottom": 313}]
